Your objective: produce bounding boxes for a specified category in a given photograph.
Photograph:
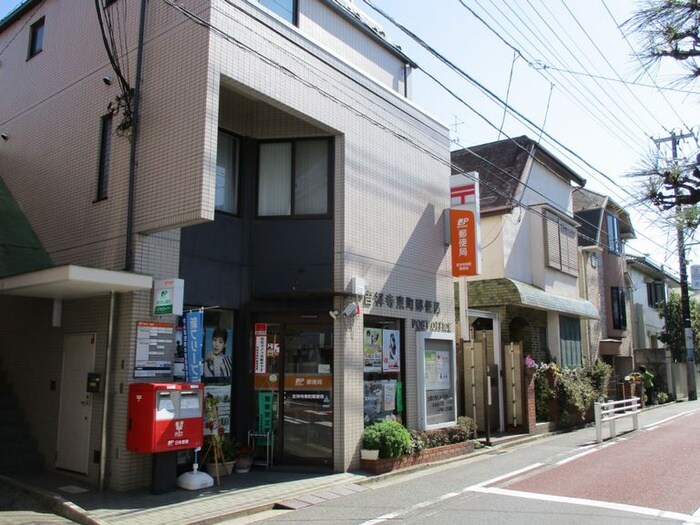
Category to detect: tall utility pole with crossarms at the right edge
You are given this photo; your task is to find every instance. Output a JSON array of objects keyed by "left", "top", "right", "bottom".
[{"left": 654, "top": 131, "right": 698, "bottom": 401}]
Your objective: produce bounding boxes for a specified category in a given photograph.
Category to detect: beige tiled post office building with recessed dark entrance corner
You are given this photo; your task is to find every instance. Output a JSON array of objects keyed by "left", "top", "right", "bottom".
[{"left": 0, "top": 0, "right": 454, "bottom": 490}]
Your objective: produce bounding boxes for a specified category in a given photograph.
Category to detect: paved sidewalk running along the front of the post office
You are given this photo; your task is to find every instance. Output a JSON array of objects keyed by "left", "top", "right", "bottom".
[{"left": 0, "top": 402, "right": 700, "bottom": 525}]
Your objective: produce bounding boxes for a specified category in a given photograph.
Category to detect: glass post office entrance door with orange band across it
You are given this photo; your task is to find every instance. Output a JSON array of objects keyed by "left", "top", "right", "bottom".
[{"left": 254, "top": 323, "right": 333, "bottom": 467}]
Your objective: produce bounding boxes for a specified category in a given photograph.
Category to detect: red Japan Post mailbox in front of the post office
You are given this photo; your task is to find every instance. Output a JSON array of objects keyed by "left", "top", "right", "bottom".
[{"left": 126, "top": 383, "right": 204, "bottom": 454}]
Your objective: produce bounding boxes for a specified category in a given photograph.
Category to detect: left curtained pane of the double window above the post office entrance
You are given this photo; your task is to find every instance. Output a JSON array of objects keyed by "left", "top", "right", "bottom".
[{"left": 258, "top": 142, "right": 292, "bottom": 216}]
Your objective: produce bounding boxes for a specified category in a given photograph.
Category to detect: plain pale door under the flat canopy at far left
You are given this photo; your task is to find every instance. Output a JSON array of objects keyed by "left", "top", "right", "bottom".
[{"left": 56, "top": 333, "right": 95, "bottom": 474}]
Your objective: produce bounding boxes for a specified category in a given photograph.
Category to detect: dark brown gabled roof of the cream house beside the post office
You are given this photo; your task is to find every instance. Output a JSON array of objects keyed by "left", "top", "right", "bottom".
[{"left": 451, "top": 135, "right": 586, "bottom": 214}]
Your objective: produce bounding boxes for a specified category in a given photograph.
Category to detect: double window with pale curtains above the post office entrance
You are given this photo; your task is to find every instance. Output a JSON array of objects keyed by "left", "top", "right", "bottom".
[{"left": 258, "top": 139, "right": 331, "bottom": 217}]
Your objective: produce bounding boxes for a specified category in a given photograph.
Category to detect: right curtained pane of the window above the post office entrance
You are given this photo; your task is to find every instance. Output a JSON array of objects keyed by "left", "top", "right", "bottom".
[{"left": 294, "top": 140, "right": 328, "bottom": 215}]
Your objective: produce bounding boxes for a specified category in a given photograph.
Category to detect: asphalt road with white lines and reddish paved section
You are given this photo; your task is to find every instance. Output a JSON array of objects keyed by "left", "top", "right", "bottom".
[{"left": 226, "top": 402, "right": 700, "bottom": 525}]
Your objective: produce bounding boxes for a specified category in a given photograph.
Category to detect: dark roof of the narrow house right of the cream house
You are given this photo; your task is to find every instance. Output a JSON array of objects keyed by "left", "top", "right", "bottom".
[{"left": 571, "top": 188, "right": 637, "bottom": 246}]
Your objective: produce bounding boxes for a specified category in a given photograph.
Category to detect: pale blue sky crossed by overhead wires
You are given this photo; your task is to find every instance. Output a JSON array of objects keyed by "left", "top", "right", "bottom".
[{"left": 0, "top": 0, "right": 700, "bottom": 274}]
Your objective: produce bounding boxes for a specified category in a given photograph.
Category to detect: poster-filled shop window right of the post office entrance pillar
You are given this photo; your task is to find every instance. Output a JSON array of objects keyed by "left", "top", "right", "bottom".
[{"left": 362, "top": 316, "right": 404, "bottom": 425}]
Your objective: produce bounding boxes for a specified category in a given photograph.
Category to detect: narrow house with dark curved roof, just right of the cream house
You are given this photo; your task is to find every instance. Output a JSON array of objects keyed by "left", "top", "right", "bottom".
[{"left": 573, "top": 188, "right": 635, "bottom": 387}]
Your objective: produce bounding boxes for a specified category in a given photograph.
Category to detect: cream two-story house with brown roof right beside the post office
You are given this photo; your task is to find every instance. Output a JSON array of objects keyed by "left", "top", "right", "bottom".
[{"left": 452, "top": 136, "right": 598, "bottom": 434}]
